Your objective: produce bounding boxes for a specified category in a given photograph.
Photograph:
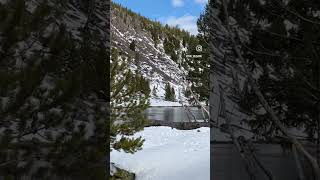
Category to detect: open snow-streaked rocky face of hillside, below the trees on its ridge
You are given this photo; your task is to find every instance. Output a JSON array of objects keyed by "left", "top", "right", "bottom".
[{"left": 111, "top": 3, "right": 195, "bottom": 106}]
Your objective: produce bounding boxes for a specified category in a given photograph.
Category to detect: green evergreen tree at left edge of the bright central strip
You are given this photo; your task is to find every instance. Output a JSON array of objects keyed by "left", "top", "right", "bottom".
[{"left": 110, "top": 49, "right": 150, "bottom": 153}]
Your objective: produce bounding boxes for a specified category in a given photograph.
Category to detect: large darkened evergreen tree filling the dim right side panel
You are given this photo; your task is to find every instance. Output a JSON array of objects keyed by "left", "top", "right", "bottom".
[{"left": 207, "top": 0, "right": 320, "bottom": 173}]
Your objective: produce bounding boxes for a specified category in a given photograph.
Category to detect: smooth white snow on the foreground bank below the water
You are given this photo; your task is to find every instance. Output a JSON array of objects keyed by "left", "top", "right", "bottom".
[{"left": 111, "top": 127, "right": 210, "bottom": 180}]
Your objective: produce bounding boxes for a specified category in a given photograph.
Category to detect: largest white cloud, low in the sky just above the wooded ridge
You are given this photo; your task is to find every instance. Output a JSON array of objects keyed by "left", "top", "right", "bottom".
[{"left": 162, "top": 15, "right": 198, "bottom": 35}]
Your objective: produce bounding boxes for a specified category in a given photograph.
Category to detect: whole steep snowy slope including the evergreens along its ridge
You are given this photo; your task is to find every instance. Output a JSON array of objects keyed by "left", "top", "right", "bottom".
[{"left": 111, "top": 4, "right": 205, "bottom": 105}]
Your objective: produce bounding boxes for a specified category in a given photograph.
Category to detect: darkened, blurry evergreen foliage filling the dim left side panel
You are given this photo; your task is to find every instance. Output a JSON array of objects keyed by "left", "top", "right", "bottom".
[{"left": 0, "top": 0, "right": 110, "bottom": 180}]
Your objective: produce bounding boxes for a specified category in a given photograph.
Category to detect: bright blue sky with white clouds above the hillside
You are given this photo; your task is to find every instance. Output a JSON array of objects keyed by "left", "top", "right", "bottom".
[{"left": 113, "top": 0, "right": 208, "bottom": 34}]
